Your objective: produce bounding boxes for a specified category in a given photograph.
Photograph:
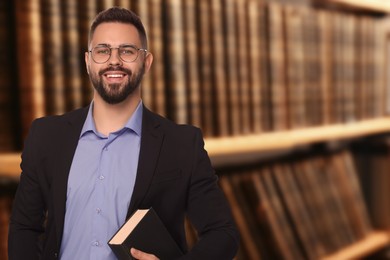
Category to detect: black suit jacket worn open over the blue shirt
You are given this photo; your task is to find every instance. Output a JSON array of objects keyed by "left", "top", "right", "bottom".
[{"left": 8, "top": 107, "right": 239, "bottom": 260}]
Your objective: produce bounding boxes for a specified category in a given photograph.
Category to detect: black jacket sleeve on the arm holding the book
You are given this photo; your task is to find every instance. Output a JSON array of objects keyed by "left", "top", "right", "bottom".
[{"left": 182, "top": 131, "right": 239, "bottom": 260}]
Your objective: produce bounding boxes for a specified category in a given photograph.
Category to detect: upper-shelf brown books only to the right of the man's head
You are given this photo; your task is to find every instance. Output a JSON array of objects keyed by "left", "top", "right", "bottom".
[{"left": 140, "top": 0, "right": 388, "bottom": 136}]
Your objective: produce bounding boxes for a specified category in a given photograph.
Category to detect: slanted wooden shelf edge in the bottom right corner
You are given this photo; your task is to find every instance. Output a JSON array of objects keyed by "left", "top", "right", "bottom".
[{"left": 322, "top": 231, "right": 390, "bottom": 260}]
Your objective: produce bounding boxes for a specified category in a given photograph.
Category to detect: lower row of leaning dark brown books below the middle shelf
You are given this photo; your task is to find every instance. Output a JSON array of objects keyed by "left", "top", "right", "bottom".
[{"left": 0, "top": 142, "right": 390, "bottom": 260}]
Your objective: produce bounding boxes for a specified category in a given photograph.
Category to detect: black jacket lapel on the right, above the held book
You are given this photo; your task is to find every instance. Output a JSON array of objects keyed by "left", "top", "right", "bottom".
[{"left": 126, "top": 107, "right": 164, "bottom": 219}]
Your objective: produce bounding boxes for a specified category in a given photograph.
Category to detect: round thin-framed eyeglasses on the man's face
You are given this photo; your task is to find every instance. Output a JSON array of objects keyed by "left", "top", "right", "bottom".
[{"left": 88, "top": 45, "right": 148, "bottom": 64}]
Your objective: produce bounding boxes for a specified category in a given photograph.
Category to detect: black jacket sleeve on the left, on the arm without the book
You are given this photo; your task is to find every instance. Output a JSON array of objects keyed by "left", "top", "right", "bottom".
[{"left": 8, "top": 120, "right": 45, "bottom": 260}]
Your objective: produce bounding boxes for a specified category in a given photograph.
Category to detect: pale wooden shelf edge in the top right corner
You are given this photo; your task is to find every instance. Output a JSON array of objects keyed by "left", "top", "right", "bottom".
[{"left": 315, "top": 0, "right": 390, "bottom": 13}]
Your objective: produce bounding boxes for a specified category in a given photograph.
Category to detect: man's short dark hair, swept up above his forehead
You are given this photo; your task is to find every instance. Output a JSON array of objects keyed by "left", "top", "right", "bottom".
[{"left": 88, "top": 7, "right": 148, "bottom": 49}]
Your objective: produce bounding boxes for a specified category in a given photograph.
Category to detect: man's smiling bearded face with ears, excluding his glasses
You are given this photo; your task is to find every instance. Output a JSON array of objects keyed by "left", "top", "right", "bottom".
[{"left": 85, "top": 23, "right": 150, "bottom": 104}]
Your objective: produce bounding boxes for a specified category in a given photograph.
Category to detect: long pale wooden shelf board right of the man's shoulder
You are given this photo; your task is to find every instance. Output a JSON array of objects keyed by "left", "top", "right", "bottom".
[{"left": 205, "top": 117, "right": 390, "bottom": 165}]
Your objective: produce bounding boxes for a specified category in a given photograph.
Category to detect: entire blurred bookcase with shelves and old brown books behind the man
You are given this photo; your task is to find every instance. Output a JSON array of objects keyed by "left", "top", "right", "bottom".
[{"left": 0, "top": 0, "right": 390, "bottom": 259}]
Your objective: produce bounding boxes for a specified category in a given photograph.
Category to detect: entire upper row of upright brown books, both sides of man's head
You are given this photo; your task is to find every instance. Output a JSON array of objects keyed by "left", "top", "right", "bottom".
[{"left": 0, "top": 0, "right": 387, "bottom": 151}]
